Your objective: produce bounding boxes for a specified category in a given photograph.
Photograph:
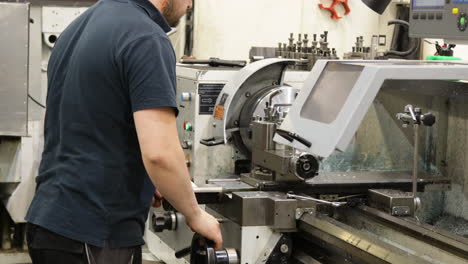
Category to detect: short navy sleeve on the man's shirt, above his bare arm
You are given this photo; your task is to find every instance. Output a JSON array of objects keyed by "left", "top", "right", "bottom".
[{"left": 119, "top": 36, "right": 178, "bottom": 114}]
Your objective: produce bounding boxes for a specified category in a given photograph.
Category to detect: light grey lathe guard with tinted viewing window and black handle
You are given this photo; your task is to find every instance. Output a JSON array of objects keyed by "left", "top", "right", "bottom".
[{"left": 274, "top": 60, "right": 468, "bottom": 157}]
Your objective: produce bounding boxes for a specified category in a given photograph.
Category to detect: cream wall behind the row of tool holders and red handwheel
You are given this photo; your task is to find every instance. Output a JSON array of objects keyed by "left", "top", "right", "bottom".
[{"left": 194, "top": 0, "right": 395, "bottom": 59}]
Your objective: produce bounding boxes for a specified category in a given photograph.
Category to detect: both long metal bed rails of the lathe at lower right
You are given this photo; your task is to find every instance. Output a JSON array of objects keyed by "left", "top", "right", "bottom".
[{"left": 298, "top": 206, "right": 468, "bottom": 264}]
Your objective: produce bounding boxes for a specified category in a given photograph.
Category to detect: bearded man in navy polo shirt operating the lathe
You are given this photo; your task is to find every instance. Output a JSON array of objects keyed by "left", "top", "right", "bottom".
[{"left": 26, "top": 0, "right": 222, "bottom": 264}]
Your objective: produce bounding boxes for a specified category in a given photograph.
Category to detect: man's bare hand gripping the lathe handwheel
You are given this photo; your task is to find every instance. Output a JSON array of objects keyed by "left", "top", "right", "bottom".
[{"left": 187, "top": 209, "right": 223, "bottom": 250}]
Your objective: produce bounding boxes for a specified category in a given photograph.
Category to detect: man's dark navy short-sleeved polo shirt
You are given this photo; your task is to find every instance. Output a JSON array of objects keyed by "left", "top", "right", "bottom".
[{"left": 26, "top": 0, "right": 177, "bottom": 248}]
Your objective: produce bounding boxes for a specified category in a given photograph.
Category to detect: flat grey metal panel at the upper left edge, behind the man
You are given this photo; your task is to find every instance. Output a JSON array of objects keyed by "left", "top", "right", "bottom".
[{"left": 0, "top": 3, "right": 29, "bottom": 136}]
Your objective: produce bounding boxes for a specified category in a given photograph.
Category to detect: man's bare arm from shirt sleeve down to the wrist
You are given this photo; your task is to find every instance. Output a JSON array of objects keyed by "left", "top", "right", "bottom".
[{"left": 134, "top": 109, "right": 200, "bottom": 220}]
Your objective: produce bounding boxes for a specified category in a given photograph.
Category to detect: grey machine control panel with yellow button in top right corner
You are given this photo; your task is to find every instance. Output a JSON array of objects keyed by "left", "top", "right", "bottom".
[{"left": 410, "top": 0, "right": 468, "bottom": 42}]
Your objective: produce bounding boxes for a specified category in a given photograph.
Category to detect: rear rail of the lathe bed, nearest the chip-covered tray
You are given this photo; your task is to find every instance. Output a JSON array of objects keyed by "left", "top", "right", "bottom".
[{"left": 339, "top": 206, "right": 468, "bottom": 263}]
